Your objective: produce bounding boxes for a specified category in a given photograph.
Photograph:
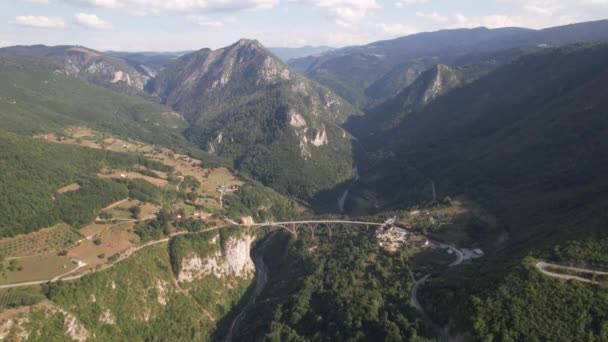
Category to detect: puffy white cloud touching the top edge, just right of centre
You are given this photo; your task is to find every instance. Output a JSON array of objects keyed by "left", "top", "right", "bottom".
[{"left": 293, "top": 0, "right": 380, "bottom": 26}]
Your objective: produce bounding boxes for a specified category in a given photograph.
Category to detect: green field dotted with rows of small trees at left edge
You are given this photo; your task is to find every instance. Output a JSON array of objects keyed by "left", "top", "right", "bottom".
[{"left": 0, "top": 224, "right": 82, "bottom": 257}]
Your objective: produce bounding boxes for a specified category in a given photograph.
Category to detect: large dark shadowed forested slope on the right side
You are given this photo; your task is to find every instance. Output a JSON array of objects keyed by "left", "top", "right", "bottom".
[{"left": 354, "top": 45, "right": 608, "bottom": 211}]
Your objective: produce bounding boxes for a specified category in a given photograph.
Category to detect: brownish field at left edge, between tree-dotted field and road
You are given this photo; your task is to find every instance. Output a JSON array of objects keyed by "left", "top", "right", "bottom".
[{"left": 0, "top": 253, "right": 76, "bottom": 284}]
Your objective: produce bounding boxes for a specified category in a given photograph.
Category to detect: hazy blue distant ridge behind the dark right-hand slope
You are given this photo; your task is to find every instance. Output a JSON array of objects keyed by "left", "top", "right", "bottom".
[{"left": 290, "top": 21, "right": 608, "bottom": 106}]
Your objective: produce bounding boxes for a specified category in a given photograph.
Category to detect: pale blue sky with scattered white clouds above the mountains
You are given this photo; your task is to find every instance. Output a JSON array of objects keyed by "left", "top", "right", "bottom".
[{"left": 0, "top": 0, "right": 608, "bottom": 51}]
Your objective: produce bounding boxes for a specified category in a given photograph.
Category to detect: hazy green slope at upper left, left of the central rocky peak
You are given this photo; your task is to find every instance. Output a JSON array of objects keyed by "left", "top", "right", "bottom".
[{"left": 0, "top": 56, "right": 186, "bottom": 145}]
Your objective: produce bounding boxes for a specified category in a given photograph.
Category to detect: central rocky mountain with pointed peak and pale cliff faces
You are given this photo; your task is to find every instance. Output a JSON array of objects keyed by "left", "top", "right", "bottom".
[{"left": 148, "top": 39, "right": 357, "bottom": 198}]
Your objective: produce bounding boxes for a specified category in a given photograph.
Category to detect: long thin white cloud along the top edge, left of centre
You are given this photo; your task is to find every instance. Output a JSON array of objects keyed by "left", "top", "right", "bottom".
[{"left": 63, "top": 0, "right": 279, "bottom": 15}]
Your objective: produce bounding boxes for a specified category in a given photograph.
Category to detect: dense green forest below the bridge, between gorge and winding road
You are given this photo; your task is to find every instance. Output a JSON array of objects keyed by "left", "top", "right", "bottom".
[{"left": 236, "top": 229, "right": 433, "bottom": 341}]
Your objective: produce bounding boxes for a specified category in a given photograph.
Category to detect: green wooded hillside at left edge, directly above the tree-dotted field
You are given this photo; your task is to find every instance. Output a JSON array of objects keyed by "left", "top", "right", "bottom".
[{"left": 0, "top": 130, "right": 166, "bottom": 236}]
